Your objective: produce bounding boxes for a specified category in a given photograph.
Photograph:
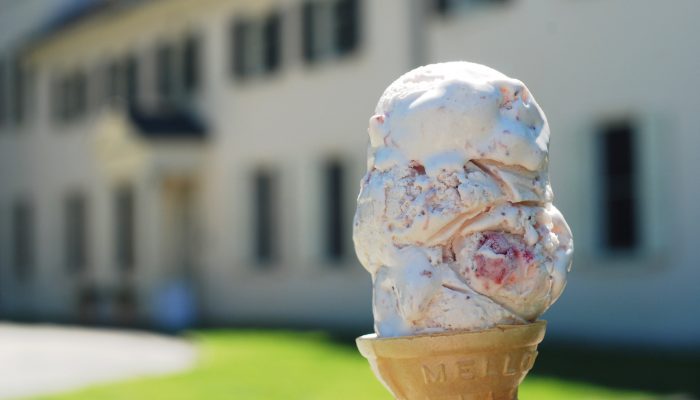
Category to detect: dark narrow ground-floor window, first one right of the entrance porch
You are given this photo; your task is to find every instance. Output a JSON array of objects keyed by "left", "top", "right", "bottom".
[{"left": 252, "top": 170, "right": 277, "bottom": 264}]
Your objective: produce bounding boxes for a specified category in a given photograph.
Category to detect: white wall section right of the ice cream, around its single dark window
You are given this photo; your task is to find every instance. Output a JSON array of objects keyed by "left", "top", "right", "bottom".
[{"left": 429, "top": 0, "right": 700, "bottom": 346}]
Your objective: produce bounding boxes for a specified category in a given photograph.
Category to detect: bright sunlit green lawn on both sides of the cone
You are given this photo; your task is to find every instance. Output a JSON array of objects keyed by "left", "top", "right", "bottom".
[{"left": 30, "top": 330, "right": 653, "bottom": 400}]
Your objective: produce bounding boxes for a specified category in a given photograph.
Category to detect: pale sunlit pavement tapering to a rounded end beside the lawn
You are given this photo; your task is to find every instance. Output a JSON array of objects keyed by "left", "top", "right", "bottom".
[{"left": 0, "top": 323, "right": 196, "bottom": 399}]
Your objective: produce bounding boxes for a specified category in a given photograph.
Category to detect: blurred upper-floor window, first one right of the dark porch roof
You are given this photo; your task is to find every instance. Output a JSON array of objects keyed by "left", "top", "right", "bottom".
[{"left": 231, "top": 14, "right": 281, "bottom": 78}]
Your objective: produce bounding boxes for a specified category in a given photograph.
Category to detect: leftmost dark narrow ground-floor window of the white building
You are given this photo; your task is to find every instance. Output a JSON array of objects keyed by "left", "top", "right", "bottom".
[{"left": 12, "top": 201, "right": 34, "bottom": 279}]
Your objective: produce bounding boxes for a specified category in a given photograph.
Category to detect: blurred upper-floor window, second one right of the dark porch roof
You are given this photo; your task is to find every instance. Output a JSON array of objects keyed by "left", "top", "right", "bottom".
[{"left": 302, "top": 0, "right": 359, "bottom": 62}]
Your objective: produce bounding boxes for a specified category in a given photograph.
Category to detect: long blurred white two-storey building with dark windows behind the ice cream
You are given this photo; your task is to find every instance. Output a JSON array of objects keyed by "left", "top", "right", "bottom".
[{"left": 0, "top": 0, "right": 700, "bottom": 346}]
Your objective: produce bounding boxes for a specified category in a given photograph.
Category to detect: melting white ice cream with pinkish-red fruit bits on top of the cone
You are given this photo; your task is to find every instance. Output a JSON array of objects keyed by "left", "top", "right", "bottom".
[{"left": 353, "top": 62, "right": 573, "bottom": 337}]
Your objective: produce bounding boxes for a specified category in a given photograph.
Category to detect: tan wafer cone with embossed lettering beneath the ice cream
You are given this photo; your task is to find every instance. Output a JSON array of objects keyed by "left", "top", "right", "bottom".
[{"left": 357, "top": 321, "right": 546, "bottom": 400}]
